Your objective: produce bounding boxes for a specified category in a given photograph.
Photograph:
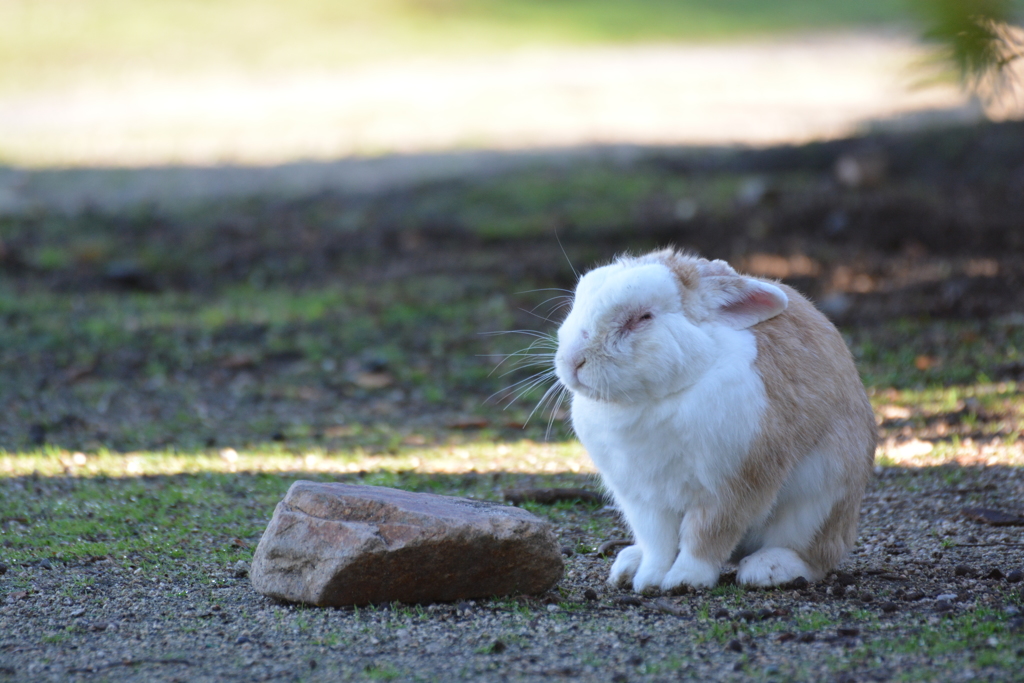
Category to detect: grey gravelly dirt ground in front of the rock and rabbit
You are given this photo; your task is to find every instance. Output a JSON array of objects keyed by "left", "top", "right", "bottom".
[{"left": 0, "top": 467, "right": 1024, "bottom": 683}]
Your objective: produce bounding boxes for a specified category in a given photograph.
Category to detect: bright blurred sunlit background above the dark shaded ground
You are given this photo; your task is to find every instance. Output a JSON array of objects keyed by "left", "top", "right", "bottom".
[{"left": 0, "top": 0, "right": 1021, "bottom": 172}]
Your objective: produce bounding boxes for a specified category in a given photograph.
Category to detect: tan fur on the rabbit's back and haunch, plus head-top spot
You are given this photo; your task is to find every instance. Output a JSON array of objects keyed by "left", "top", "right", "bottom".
[{"left": 658, "top": 253, "right": 877, "bottom": 571}]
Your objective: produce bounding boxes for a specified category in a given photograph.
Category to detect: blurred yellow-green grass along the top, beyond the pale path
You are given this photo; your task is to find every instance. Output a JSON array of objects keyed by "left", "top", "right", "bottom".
[{"left": 0, "top": 0, "right": 907, "bottom": 92}]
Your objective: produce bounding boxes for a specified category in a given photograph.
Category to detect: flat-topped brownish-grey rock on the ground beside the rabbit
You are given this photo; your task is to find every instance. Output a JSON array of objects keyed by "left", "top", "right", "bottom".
[{"left": 250, "top": 481, "right": 562, "bottom": 606}]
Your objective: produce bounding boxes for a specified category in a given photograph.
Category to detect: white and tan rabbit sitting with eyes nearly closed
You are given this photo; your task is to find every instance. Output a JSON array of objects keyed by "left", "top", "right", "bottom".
[{"left": 555, "top": 250, "right": 876, "bottom": 591}]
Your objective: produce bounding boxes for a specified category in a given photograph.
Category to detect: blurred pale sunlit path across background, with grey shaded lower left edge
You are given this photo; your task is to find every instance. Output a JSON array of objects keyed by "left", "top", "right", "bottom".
[{"left": 0, "top": 30, "right": 1007, "bottom": 211}]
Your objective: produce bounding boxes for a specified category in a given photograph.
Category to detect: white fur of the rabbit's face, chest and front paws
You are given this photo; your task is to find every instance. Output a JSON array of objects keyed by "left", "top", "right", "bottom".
[{"left": 556, "top": 259, "right": 768, "bottom": 591}]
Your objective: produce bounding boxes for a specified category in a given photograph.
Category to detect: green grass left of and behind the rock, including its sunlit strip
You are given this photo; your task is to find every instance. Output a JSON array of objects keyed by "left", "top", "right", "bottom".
[{"left": 0, "top": 444, "right": 597, "bottom": 569}]
